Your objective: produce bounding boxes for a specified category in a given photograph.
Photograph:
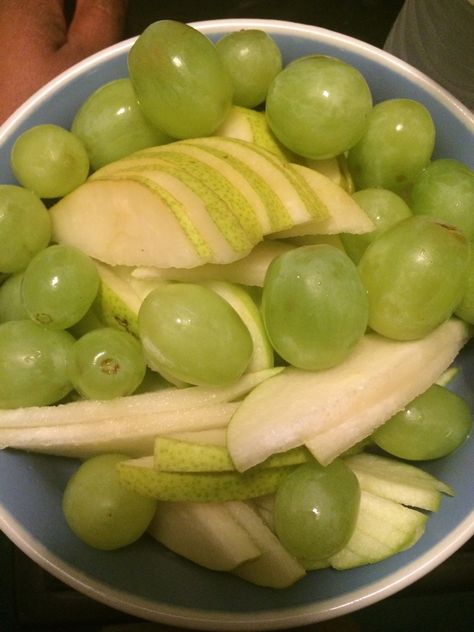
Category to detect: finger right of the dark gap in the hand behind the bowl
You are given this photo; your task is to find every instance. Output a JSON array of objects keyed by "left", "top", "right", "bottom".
[{"left": 66, "top": 0, "right": 128, "bottom": 58}]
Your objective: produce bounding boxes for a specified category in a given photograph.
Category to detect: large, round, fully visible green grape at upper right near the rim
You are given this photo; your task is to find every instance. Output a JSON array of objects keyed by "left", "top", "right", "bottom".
[{"left": 266, "top": 55, "right": 372, "bottom": 158}]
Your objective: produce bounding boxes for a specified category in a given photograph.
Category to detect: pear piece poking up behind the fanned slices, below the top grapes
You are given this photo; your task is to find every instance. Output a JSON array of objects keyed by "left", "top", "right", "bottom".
[{"left": 214, "top": 105, "right": 296, "bottom": 162}]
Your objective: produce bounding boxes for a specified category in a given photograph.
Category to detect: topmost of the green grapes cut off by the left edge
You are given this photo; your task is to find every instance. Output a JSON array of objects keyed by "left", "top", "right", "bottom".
[{"left": 0, "top": 184, "right": 51, "bottom": 274}]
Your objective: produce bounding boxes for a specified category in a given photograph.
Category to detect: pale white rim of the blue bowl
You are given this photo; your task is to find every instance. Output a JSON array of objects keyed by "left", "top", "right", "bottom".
[{"left": 0, "top": 18, "right": 474, "bottom": 632}]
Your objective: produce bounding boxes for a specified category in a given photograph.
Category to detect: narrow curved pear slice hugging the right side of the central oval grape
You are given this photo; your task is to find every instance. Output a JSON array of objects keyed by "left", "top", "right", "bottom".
[{"left": 205, "top": 281, "right": 274, "bottom": 373}]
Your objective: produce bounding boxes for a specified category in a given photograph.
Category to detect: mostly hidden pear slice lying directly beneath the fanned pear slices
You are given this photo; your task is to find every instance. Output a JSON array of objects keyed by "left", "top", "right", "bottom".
[{"left": 132, "top": 239, "right": 294, "bottom": 287}]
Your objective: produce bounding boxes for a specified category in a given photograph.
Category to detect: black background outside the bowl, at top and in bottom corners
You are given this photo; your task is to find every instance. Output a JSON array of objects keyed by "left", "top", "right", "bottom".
[{"left": 0, "top": 0, "right": 474, "bottom": 632}]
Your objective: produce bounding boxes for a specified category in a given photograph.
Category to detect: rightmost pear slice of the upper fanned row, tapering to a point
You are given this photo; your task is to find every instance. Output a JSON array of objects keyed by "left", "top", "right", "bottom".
[{"left": 273, "top": 165, "right": 375, "bottom": 239}]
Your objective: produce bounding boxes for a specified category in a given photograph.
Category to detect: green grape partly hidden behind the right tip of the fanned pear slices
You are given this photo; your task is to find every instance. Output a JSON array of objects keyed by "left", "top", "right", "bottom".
[{"left": 340, "top": 189, "right": 412, "bottom": 263}]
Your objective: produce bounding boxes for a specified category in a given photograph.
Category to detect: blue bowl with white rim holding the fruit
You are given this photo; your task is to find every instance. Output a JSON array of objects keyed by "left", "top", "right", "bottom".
[{"left": 0, "top": 20, "right": 474, "bottom": 632}]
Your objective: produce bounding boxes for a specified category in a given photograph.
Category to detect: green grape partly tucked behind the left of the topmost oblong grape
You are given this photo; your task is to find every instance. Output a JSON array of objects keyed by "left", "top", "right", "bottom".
[{"left": 71, "top": 78, "right": 171, "bottom": 170}]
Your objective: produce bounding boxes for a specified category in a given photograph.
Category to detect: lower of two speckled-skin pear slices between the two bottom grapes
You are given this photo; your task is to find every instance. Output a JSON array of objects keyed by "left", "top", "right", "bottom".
[{"left": 117, "top": 456, "right": 294, "bottom": 502}]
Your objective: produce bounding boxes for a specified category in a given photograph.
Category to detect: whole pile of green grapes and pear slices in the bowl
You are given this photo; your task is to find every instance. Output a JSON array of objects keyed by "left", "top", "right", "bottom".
[{"left": 0, "top": 20, "right": 474, "bottom": 589}]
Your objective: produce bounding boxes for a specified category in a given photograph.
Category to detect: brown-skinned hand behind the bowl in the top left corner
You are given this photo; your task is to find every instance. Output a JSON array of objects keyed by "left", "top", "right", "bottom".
[{"left": 0, "top": 0, "right": 128, "bottom": 123}]
